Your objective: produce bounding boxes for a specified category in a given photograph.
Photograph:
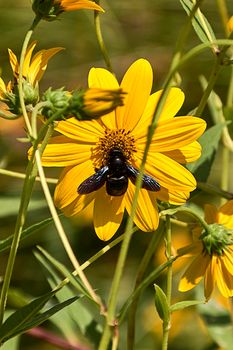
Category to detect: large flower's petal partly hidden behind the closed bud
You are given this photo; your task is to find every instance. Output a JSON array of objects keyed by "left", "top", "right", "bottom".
[{"left": 88, "top": 68, "right": 119, "bottom": 129}]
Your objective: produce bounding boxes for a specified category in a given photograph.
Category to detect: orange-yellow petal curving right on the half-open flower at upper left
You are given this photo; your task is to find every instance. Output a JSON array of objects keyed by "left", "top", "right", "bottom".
[{"left": 27, "top": 47, "right": 63, "bottom": 85}]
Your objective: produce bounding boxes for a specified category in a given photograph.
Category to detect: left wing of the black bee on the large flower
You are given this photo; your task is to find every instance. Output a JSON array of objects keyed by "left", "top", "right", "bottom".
[{"left": 78, "top": 165, "right": 108, "bottom": 194}]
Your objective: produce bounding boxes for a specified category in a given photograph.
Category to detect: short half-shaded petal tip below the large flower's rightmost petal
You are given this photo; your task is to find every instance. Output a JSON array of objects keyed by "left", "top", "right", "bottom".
[{"left": 162, "top": 141, "right": 201, "bottom": 164}]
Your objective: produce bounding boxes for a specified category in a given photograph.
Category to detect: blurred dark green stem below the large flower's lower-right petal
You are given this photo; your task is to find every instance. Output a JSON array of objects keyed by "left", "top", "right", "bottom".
[{"left": 127, "top": 225, "right": 164, "bottom": 350}]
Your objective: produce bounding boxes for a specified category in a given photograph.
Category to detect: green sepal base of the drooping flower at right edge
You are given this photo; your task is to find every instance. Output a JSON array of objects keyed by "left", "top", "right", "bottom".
[{"left": 200, "top": 224, "right": 233, "bottom": 255}]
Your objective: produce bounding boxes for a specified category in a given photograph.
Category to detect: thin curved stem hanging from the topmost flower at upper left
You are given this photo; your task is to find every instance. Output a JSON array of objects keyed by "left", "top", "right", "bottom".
[{"left": 18, "top": 17, "right": 40, "bottom": 135}]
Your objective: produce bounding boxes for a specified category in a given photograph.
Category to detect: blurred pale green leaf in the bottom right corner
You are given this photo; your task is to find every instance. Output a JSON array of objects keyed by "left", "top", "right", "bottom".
[{"left": 198, "top": 300, "right": 233, "bottom": 350}]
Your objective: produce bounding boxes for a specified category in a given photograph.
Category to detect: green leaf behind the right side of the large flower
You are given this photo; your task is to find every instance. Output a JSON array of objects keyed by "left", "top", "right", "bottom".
[{"left": 187, "top": 123, "right": 226, "bottom": 182}]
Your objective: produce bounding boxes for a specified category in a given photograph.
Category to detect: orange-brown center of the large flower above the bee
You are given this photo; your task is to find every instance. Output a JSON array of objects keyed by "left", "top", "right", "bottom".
[{"left": 93, "top": 129, "right": 136, "bottom": 168}]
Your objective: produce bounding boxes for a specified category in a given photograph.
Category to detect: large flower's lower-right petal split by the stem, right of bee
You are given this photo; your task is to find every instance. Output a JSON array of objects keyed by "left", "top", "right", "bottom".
[{"left": 125, "top": 182, "right": 159, "bottom": 232}]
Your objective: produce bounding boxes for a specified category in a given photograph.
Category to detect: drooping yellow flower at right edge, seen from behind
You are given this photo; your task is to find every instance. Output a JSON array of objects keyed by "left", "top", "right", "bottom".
[{"left": 179, "top": 200, "right": 233, "bottom": 300}]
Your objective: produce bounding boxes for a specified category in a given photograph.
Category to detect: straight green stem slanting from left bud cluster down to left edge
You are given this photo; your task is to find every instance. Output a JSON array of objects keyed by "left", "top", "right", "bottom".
[{"left": 0, "top": 123, "right": 50, "bottom": 325}]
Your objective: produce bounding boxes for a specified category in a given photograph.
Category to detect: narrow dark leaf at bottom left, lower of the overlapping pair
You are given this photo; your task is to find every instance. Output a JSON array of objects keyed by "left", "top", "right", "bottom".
[{"left": 2, "top": 296, "right": 79, "bottom": 342}]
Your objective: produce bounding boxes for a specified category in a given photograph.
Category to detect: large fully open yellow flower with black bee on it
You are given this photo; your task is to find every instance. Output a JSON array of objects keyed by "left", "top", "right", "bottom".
[{"left": 39, "top": 59, "right": 206, "bottom": 240}]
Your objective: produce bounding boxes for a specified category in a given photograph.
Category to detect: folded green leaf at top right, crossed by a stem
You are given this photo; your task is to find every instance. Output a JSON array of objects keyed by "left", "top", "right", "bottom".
[{"left": 180, "top": 0, "right": 218, "bottom": 51}]
